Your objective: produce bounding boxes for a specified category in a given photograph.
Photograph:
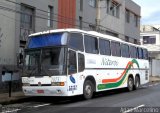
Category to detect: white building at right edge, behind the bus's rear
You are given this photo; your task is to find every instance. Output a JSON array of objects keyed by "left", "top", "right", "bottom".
[{"left": 140, "top": 25, "right": 160, "bottom": 76}]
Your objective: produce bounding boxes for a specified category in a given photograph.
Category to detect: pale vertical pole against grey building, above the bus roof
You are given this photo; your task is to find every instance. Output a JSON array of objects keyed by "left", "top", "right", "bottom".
[{"left": 96, "top": 0, "right": 100, "bottom": 31}]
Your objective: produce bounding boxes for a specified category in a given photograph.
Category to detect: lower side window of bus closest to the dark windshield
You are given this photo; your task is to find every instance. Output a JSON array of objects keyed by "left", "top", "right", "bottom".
[{"left": 68, "top": 50, "right": 77, "bottom": 74}]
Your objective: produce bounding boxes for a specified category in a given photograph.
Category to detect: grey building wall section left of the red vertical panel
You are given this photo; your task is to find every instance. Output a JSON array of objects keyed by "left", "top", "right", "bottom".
[{"left": 0, "top": 0, "right": 56, "bottom": 93}]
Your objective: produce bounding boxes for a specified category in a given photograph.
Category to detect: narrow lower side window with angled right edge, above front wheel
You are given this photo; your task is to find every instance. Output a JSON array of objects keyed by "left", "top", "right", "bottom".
[{"left": 78, "top": 53, "right": 85, "bottom": 72}]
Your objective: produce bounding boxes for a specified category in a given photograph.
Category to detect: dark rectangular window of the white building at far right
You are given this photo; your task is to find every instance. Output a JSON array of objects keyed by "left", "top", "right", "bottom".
[{"left": 143, "top": 36, "right": 156, "bottom": 44}]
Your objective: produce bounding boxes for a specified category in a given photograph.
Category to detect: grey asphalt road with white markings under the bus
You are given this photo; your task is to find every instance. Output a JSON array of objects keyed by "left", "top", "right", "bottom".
[{"left": 2, "top": 83, "right": 160, "bottom": 113}]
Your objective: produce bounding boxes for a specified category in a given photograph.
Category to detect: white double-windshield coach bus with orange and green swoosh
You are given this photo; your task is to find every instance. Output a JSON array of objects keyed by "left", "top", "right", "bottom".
[{"left": 22, "top": 29, "right": 149, "bottom": 99}]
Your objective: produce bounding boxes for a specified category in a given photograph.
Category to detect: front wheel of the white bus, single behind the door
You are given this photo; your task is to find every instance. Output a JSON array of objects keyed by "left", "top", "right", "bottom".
[{"left": 83, "top": 80, "right": 94, "bottom": 99}]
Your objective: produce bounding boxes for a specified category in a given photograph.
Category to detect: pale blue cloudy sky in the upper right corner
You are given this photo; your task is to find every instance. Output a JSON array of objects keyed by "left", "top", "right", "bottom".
[{"left": 132, "top": 0, "right": 160, "bottom": 25}]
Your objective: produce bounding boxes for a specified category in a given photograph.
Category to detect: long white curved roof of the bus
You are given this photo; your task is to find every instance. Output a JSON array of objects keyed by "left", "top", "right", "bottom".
[{"left": 29, "top": 28, "right": 146, "bottom": 48}]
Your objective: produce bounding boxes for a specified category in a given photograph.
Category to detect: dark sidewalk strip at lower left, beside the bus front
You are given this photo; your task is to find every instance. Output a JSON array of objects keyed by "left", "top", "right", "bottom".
[{"left": 0, "top": 91, "right": 27, "bottom": 104}]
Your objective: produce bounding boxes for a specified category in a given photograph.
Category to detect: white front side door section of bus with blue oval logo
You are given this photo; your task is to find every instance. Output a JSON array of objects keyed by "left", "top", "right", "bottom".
[{"left": 68, "top": 49, "right": 84, "bottom": 94}]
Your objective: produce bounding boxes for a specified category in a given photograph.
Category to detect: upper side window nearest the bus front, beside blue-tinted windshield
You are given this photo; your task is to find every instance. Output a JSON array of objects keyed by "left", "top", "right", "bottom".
[{"left": 69, "top": 33, "right": 84, "bottom": 51}]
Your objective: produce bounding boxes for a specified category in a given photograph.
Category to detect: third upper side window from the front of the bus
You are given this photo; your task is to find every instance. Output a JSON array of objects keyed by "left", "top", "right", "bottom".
[{"left": 99, "top": 39, "right": 111, "bottom": 55}]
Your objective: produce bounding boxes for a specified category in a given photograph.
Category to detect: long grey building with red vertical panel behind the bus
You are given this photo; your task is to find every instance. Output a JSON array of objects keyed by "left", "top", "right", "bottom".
[{"left": 0, "top": 0, "right": 140, "bottom": 92}]
